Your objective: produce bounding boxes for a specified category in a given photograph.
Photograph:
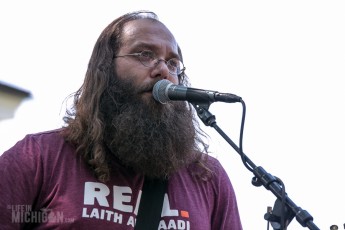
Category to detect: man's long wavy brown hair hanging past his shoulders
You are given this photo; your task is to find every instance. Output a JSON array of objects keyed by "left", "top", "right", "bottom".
[{"left": 63, "top": 11, "right": 210, "bottom": 182}]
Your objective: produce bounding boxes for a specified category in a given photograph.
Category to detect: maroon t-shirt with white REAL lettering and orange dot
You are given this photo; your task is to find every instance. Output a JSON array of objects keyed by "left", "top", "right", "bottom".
[{"left": 0, "top": 130, "right": 242, "bottom": 230}]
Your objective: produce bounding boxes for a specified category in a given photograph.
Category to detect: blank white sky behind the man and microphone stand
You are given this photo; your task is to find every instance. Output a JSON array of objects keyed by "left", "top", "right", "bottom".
[{"left": 0, "top": 0, "right": 345, "bottom": 230}]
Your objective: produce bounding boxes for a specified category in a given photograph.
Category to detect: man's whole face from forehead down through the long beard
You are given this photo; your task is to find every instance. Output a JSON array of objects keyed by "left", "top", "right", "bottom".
[{"left": 101, "top": 19, "right": 197, "bottom": 178}]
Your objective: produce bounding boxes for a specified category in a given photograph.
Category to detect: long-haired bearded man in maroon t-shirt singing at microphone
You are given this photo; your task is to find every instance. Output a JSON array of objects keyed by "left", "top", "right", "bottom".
[{"left": 0, "top": 11, "right": 242, "bottom": 230}]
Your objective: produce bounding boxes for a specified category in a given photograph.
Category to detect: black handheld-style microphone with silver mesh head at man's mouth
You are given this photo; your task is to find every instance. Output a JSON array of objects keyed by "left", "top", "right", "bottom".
[{"left": 152, "top": 79, "right": 242, "bottom": 104}]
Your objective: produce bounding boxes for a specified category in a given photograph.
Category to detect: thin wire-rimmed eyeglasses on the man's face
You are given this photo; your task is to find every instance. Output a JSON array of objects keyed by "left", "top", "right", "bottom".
[{"left": 115, "top": 50, "right": 186, "bottom": 75}]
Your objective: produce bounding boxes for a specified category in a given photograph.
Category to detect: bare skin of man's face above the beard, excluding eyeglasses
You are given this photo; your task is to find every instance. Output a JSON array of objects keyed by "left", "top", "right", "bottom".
[{"left": 114, "top": 19, "right": 179, "bottom": 102}]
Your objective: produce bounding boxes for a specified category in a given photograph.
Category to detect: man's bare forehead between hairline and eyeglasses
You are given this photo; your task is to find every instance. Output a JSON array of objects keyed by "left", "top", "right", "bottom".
[{"left": 121, "top": 19, "right": 177, "bottom": 53}]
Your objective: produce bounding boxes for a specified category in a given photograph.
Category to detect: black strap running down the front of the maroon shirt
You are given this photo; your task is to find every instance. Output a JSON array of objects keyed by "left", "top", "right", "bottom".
[{"left": 134, "top": 178, "right": 167, "bottom": 230}]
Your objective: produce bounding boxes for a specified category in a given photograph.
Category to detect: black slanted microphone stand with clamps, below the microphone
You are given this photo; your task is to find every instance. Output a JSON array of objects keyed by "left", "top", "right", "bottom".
[{"left": 191, "top": 100, "right": 320, "bottom": 230}]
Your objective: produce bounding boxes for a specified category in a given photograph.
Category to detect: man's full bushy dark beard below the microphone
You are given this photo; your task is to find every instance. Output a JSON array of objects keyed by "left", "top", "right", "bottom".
[{"left": 101, "top": 80, "right": 197, "bottom": 179}]
